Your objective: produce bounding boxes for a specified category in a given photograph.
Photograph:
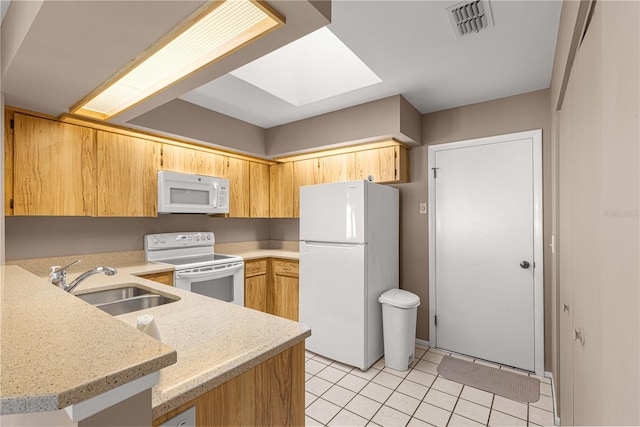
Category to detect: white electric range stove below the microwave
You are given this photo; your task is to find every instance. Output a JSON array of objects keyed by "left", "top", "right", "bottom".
[{"left": 144, "top": 232, "right": 244, "bottom": 305}]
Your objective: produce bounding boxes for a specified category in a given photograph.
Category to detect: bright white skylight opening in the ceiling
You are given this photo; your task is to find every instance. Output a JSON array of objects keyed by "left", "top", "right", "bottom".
[{"left": 230, "top": 27, "right": 382, "bottom": 107}]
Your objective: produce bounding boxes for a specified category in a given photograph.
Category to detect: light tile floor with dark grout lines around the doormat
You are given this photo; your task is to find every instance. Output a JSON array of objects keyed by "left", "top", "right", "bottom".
[{"left": 305, "top": 347, "right": 554, "bottom": 427}]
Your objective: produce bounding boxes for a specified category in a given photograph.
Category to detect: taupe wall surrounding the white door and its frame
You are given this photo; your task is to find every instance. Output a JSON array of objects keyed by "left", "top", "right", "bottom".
[{"left": 396, "top": 89, "right": 551, "bottom": 366}]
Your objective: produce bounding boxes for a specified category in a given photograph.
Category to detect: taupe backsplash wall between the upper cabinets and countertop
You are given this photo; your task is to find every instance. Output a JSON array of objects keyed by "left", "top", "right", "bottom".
[{"left": 6, "top": 215, "right": 270, "bottom": 261}]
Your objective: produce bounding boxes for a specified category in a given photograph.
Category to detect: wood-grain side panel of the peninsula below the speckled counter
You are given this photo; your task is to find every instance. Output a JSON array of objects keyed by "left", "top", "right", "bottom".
[{"left": 153, "top": 342, "right": 304, "bottom": 426}]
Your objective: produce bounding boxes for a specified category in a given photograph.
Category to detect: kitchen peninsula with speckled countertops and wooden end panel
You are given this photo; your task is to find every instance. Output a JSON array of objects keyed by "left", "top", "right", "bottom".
[{"left": 0, "top": 262, "right": 311, "bottom": 425}]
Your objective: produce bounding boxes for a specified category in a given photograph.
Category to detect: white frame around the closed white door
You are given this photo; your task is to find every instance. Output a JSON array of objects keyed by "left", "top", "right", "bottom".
[{"left": 427, "top": 129, "right": 544, "bottom": 376}]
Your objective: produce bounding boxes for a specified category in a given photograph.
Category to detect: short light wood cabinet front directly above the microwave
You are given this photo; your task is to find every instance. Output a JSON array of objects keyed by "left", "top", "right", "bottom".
[{"left": 161, "top": 144, "right": 227, "bottom": 178}]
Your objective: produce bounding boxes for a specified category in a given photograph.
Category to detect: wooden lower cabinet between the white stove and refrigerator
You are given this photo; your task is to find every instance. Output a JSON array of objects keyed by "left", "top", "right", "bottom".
[{"left": 244, "top": 258, "right": 299, "bottom": 321}]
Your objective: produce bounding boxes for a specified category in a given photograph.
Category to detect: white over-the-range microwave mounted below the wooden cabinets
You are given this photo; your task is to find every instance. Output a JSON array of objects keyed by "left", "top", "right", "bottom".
[{"left": 158, "top": 171, "right": 229, "bottom": 214}]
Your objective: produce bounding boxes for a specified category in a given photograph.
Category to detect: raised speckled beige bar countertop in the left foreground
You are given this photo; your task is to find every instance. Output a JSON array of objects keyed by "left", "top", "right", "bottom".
[{"left": 0, "top": 266, "right": 176, "bottom": 414}]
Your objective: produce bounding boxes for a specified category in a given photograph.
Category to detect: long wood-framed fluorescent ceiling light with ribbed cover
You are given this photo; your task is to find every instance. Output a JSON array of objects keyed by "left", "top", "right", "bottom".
[{"left": 70, "top": 0, "right": 284, "bottom": 120}]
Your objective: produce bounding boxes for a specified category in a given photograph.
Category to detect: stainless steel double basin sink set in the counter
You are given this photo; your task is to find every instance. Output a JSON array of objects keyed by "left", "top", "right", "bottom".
[{"left": 76, "top": 283, "right": 180, "bottom": 316}]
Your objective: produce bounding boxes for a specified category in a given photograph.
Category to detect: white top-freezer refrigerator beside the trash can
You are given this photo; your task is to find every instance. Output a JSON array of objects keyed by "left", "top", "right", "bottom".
[{"left": 300, "top": 181, "right": 399, "bottom": 370}]
